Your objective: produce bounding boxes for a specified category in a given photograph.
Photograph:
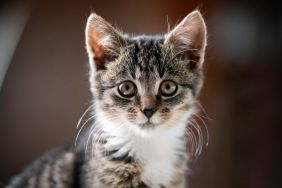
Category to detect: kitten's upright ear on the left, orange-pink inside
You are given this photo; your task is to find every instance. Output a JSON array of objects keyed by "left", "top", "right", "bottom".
[{"left": 85, "top": 13, "right": 125, "bottom": 70}]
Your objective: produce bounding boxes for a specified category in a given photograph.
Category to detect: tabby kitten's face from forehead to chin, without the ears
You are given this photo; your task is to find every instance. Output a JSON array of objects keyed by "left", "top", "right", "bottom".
[{"left": 95, "top": 38, "right": 202, "bottom": 128}]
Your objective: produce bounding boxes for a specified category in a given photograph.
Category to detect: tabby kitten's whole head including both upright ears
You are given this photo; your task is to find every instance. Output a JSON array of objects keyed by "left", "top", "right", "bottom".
[{"left": 86, "top": 11, "right": 206, "bottom": 134}]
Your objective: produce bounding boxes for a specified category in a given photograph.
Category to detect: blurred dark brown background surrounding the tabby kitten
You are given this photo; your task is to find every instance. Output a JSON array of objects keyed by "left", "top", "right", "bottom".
[{"left": 0, "top": 0, "right": 282, "bottom": 188}]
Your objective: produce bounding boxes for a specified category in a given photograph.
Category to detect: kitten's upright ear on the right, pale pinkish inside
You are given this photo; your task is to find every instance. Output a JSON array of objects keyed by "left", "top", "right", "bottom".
[{"left": 164, "top": 10, "right": 207, "bottom": 68}]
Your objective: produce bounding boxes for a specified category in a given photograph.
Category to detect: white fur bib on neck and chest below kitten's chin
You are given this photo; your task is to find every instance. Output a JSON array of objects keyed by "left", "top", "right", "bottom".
[{"left": 99, "top": 119, "right": 188, "bottom": 187}]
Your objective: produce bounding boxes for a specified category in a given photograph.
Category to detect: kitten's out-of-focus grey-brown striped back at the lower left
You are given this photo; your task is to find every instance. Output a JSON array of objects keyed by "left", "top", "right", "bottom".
[{"left": 6, "top": 144, "right": 82, "bottom": 188}]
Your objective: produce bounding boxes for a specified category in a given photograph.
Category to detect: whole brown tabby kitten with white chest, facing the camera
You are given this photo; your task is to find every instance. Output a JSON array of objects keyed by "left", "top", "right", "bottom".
[{"left": 7, "top": 11, "right": 206, "bottom": 188}]
